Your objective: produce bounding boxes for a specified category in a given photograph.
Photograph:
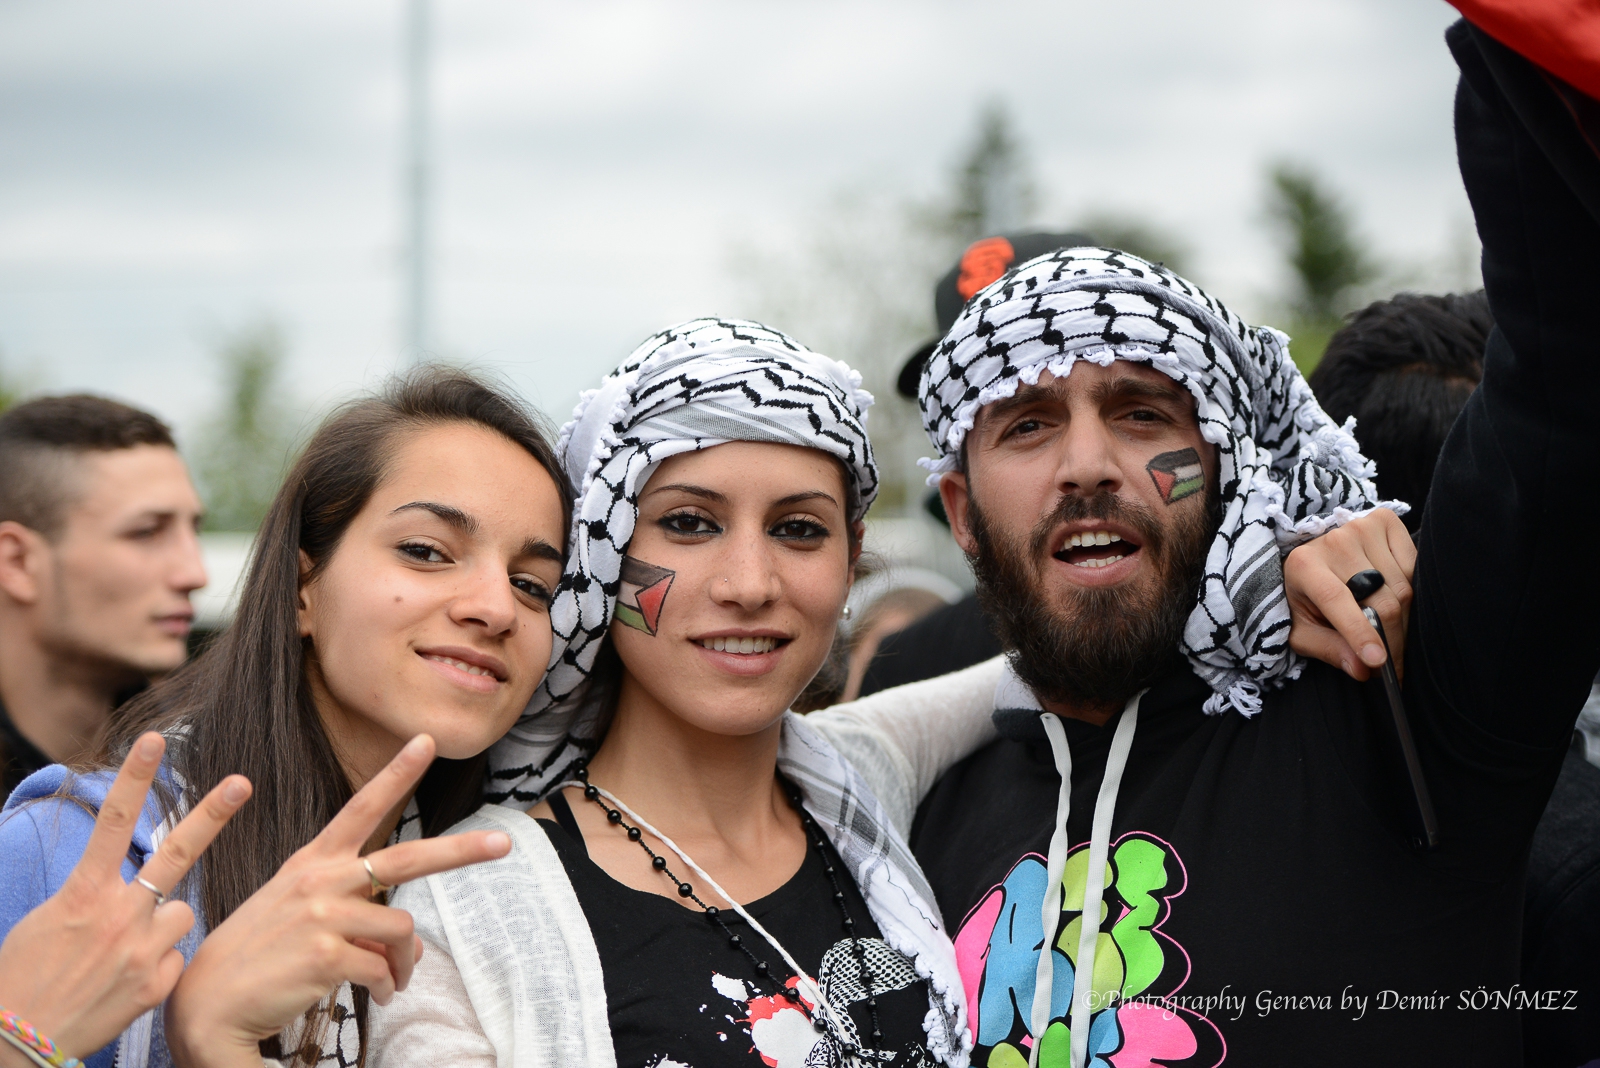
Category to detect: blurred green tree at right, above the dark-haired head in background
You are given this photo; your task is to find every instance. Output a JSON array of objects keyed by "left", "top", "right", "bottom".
[{"left": 1267, "top": 163, "right": 1379, "bottom": 374}]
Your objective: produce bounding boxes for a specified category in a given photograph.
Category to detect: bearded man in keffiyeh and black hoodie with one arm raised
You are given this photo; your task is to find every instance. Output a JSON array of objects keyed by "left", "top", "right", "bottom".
[{"left": 912, "top": 24, "right": 1600, "bottom": 1068}]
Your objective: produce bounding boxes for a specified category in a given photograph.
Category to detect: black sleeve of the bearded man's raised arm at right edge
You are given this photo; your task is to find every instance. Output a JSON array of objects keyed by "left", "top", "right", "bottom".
[{"left": 1406, "top": 22, "right": 1600, "bottom": 757}]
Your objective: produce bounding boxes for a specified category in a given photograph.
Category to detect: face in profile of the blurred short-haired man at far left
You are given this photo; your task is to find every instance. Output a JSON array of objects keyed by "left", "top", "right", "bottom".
[{"left": 35, "top": 444, "right": 206, "bottom": 676}]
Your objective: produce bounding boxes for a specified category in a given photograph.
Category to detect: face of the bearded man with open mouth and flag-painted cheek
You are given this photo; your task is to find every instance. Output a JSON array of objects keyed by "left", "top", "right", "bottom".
[{"left": 939, "top": 360, "right": 1218, "bottom": 705}]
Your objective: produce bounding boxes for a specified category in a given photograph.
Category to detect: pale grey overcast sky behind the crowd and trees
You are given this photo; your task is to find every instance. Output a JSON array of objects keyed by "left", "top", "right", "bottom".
[{"left": 0, "top": 0, "right": 1470, "bottom": 441}]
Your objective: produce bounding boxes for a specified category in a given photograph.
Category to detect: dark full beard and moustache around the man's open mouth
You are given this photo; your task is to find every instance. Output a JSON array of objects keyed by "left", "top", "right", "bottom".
[{"left": 968, "top": 482, "right": 1221, "bottom": 707}]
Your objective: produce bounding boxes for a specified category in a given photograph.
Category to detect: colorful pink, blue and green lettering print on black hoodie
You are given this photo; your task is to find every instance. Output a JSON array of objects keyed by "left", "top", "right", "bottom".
[{"left": 955, "top": 831, "right": 1227, "bottom": 1068}]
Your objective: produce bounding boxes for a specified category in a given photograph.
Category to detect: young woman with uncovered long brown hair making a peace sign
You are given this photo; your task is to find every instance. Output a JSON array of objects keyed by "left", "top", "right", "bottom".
[{"left": 0, "top": 369, "right": 571, "bottom": 1068}]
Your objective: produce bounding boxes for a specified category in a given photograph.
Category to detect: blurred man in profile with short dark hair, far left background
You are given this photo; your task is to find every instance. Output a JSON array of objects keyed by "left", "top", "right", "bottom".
[{"left": 0, "top": 395, "right": 205, "bottom": 799}]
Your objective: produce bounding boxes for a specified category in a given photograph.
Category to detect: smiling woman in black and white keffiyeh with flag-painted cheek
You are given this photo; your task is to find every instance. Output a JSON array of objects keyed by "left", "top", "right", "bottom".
[{"left": 374, "top": 320, "right": 997, "bottom": 1066}]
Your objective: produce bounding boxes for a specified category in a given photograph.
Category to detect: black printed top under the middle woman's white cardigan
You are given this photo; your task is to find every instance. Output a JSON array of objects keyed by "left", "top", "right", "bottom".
[{"left": 539, "top": 791, "right": 934, "bottom": 1068}]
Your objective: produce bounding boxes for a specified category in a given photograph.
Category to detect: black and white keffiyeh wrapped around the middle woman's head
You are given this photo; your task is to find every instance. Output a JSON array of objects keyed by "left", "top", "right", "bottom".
[{"left": 490, "top": 318, "right": 878, "bottom": 803}]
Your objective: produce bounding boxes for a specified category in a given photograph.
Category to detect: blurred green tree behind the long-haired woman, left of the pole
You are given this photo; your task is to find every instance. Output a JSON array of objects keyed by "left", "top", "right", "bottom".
[{"left": 195, "top": 323, "right": 296, "bottom": 531}]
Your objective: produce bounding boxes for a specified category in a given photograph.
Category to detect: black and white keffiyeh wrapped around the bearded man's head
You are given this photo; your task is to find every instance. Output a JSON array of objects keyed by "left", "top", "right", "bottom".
[{"left": 920, "top": 248, "right": 1406, "bottom": 716}]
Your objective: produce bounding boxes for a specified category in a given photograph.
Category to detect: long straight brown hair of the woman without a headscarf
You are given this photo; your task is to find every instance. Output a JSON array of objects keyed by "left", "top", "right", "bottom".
[{"left": 102, "top": 366, "right": 573, "bottom": 1063}]
